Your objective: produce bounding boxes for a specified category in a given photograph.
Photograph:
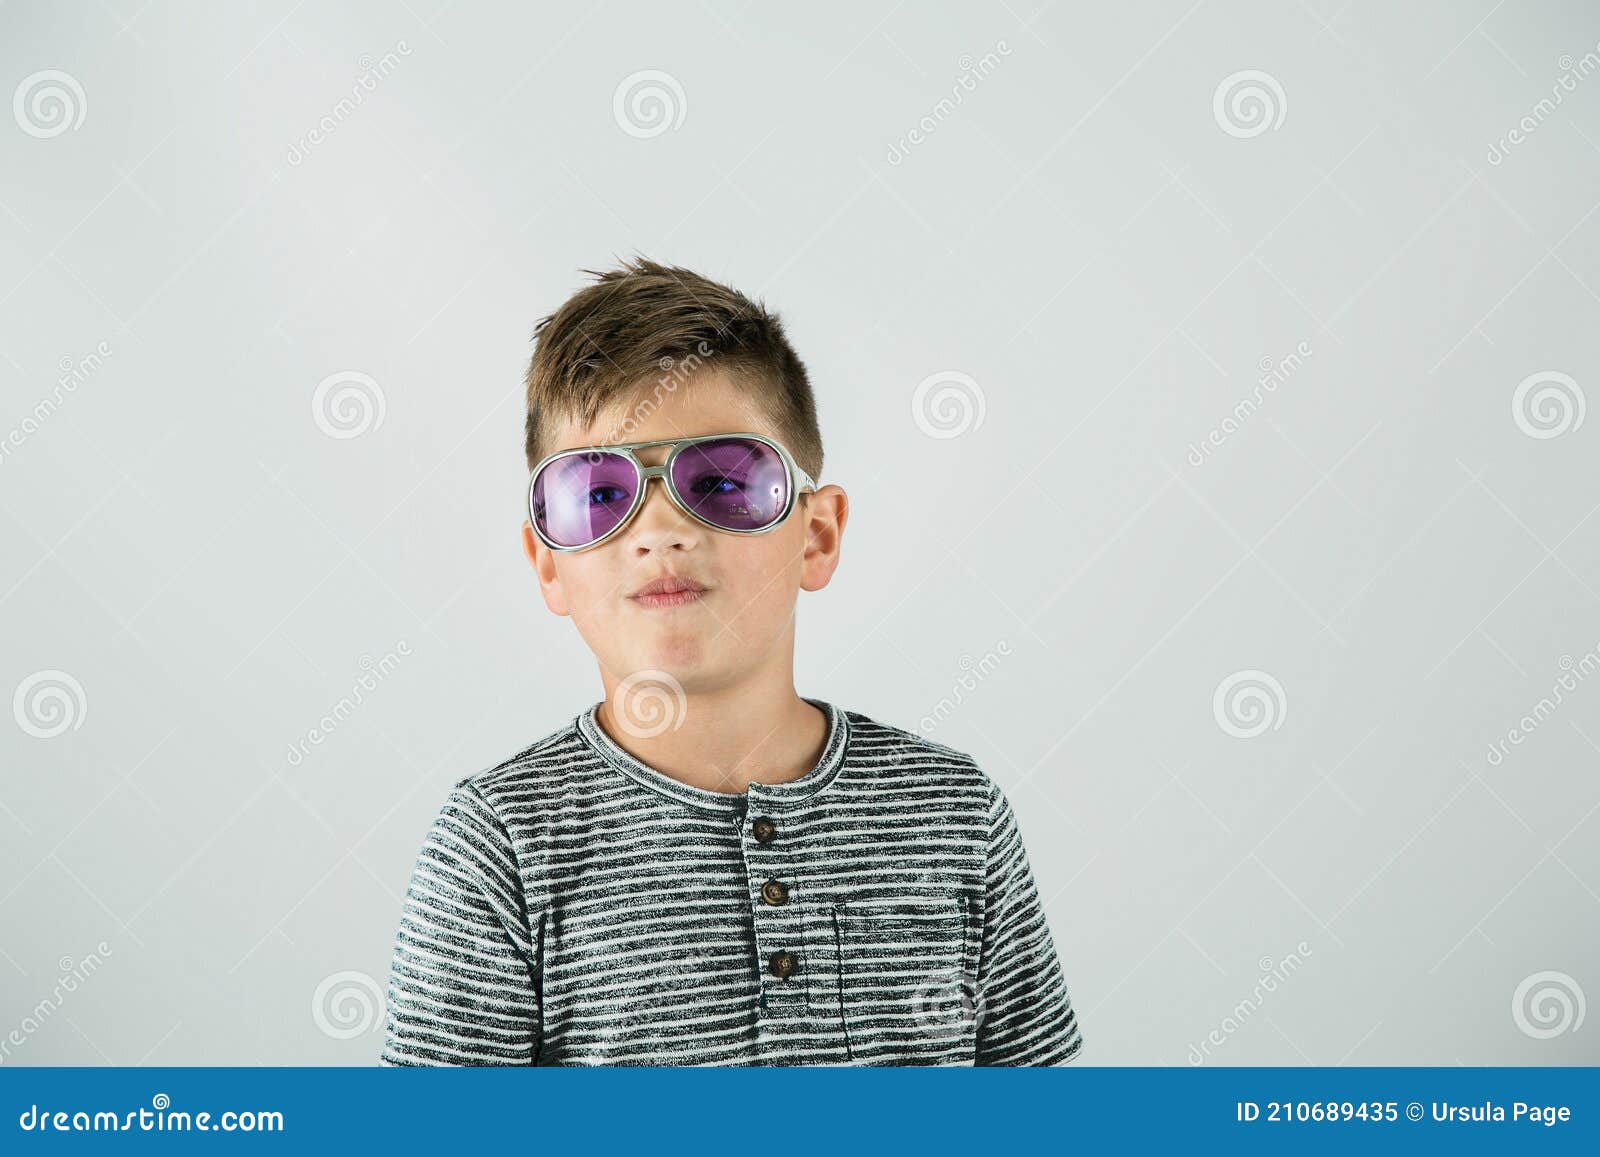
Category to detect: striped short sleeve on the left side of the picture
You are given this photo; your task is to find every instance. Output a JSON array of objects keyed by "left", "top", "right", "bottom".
[{"left": 379, "top": 783, "right": 541, "bottom": 1066}]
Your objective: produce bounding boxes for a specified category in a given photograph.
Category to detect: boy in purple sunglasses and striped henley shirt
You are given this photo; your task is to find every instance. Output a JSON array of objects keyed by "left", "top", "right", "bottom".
[{"left": 381, "top": 259, "right": 1082, "bottom": 1066}]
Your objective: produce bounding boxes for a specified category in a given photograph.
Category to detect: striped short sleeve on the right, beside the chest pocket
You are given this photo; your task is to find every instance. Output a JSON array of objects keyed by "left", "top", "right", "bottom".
[{"left": 974, "top": 786, "right": 1083, "bottom": 1066}]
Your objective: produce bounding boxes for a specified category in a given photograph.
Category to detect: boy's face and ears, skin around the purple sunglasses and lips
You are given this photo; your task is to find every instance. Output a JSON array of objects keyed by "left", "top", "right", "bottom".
[{"left": 522, "top": 370, "right": 848, "bottom": 693}]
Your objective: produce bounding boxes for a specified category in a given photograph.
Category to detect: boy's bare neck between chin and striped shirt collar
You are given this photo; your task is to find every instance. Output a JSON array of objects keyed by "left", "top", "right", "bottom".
[{"left": 597, "top": 682, "right": 827, "bottom": 794}]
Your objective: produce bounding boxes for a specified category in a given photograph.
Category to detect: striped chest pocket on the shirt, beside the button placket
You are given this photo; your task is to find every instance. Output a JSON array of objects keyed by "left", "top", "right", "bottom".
[{"left": 832, "top": 893, "right": 978, "bottom": 1064}]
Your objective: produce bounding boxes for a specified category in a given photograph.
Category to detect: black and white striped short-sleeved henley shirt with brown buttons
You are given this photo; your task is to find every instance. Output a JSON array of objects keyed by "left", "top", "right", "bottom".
[{"left": 381, "top": 699, "right": 1082, "bottom": 1066}]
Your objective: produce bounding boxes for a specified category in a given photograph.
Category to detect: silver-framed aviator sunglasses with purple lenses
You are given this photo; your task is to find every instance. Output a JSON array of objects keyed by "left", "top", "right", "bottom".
[{"left": 528, "top": 434, "right": 816, "bottom": 550}]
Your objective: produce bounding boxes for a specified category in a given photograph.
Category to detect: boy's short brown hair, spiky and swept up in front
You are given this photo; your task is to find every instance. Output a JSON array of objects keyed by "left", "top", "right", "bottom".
[{"left": 523, "top": 256, "right": 822, "bottom": 480}]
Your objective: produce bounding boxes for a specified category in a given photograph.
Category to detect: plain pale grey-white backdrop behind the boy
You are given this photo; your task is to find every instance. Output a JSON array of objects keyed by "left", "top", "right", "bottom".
[{"left": 0, "top": 0, "right": 1600, "bottom": 1064}]
